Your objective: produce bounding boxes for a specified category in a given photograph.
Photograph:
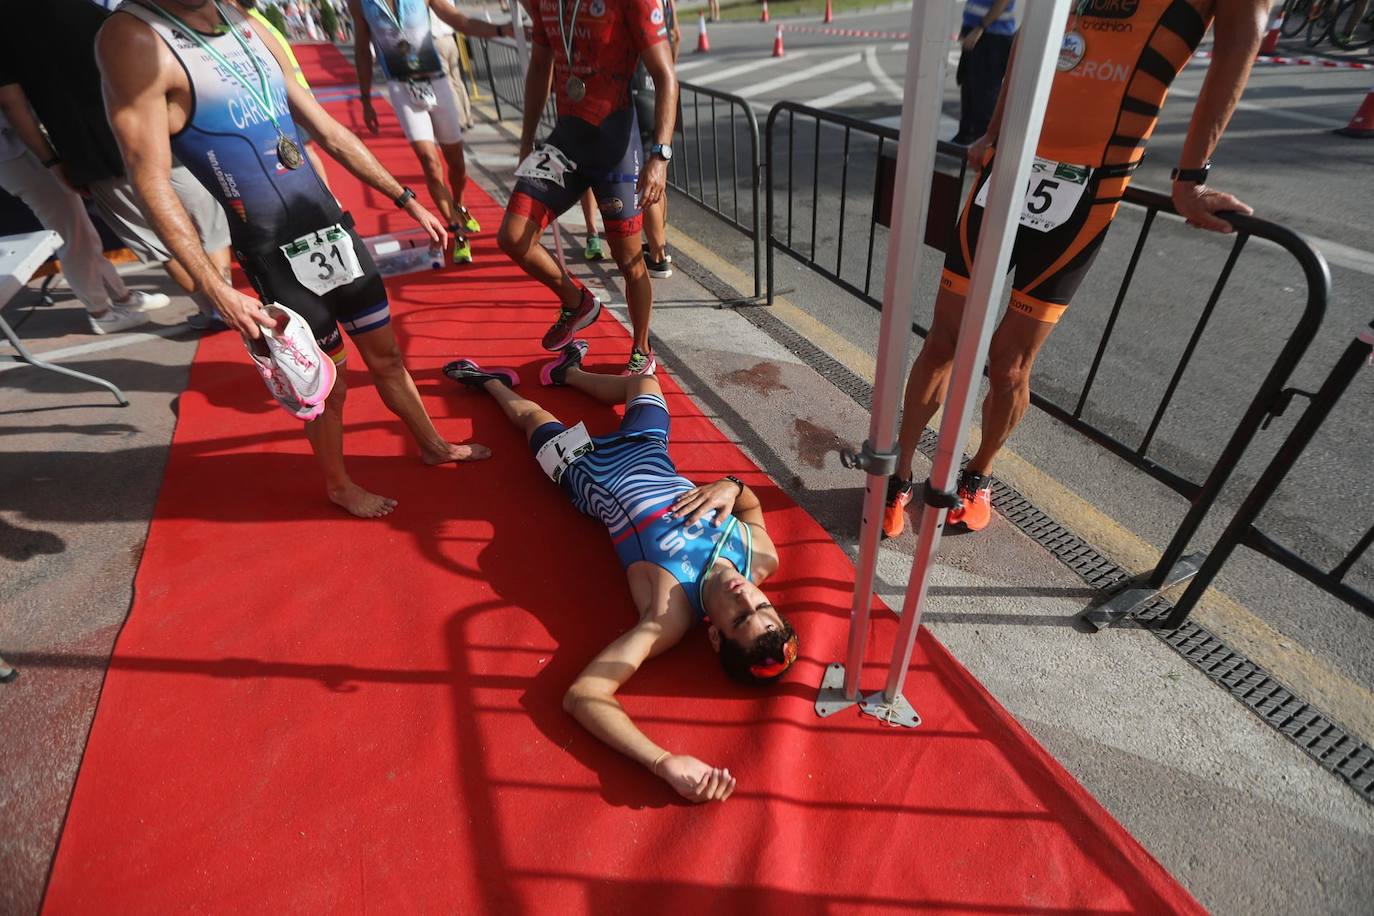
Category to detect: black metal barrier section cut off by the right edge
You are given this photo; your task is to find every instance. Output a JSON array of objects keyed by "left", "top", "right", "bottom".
[{"left": 1164, "top": 321, "right": 1374, "bottom": 629}]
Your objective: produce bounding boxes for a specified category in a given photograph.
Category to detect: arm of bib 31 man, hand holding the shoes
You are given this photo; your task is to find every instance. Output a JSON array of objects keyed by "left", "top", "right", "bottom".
[{"left": 96, "top": 15, "right": 272, "bottom": 338}]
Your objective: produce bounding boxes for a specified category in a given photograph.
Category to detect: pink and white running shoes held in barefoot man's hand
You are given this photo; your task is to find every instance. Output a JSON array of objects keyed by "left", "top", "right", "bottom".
[{"left": 243, "top": 302, "right": 337, "bottom": 420}]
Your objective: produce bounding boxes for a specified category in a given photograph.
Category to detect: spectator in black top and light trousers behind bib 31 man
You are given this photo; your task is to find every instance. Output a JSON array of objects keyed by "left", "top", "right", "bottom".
[{"left": 0, "top": 0, "right": 229, "bottom": 330}]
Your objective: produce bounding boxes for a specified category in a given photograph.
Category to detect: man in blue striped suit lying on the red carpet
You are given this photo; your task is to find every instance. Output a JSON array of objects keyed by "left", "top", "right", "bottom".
[{"left": 444, "top": 341, "right": 797, "bottom": 802}]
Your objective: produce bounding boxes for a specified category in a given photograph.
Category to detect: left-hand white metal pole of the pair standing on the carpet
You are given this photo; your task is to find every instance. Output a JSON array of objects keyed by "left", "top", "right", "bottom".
[{"left": 816, "top": 0, "right": 955, "bottom": 715}]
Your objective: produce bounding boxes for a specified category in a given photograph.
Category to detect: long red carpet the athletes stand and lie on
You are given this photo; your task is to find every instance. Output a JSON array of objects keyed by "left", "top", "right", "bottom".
[{"left": 45, "top": 48, "right": 1198, "bottom": 916}]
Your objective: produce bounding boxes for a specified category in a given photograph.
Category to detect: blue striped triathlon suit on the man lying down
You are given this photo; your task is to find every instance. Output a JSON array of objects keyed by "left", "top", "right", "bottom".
[{"left": 529, "top": 394, "right": 750, "bottom": 619}]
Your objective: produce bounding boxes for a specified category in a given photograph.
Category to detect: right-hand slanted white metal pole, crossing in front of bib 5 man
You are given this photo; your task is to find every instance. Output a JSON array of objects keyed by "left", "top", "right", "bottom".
[{"left": 864, "top": 0, "right": 1069, "bottom": 724}]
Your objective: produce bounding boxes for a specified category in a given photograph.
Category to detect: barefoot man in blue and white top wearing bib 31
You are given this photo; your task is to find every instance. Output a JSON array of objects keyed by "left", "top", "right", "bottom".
[{"left": 96, "top": 0, "right": 489, "bottom": 518}]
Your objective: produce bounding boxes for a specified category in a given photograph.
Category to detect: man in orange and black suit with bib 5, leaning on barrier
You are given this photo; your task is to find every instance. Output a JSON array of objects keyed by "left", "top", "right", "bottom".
[{"left": 883, "top": 0, "right": 1270, "bottom": 537}]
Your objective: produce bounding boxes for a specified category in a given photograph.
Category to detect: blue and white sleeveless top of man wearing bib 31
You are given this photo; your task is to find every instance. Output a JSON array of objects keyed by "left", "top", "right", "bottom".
[{"left": 120, "top": 0, "right": 342, "bottom": 255}]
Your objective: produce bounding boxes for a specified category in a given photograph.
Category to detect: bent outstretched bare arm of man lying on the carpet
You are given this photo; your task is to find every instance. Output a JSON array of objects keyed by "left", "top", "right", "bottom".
[{"left": 563, "top": 596, "right": 735, "bottom": 802}]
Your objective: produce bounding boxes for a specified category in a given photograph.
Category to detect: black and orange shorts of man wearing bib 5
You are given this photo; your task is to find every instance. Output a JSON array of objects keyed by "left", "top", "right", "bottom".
[{"left": 940, "top": 157, "right": 1129, "bottom": 324}]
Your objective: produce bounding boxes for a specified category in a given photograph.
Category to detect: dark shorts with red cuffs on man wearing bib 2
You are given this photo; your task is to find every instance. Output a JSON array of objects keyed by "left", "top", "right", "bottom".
[{"left": 506, "top": 104, "right": 643, "bottom": 238}]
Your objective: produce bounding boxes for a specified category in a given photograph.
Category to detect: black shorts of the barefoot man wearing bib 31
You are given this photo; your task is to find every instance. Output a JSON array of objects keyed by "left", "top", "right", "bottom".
[{"left": 234, "top": 213, "right": 392, "bottom": 363}]
